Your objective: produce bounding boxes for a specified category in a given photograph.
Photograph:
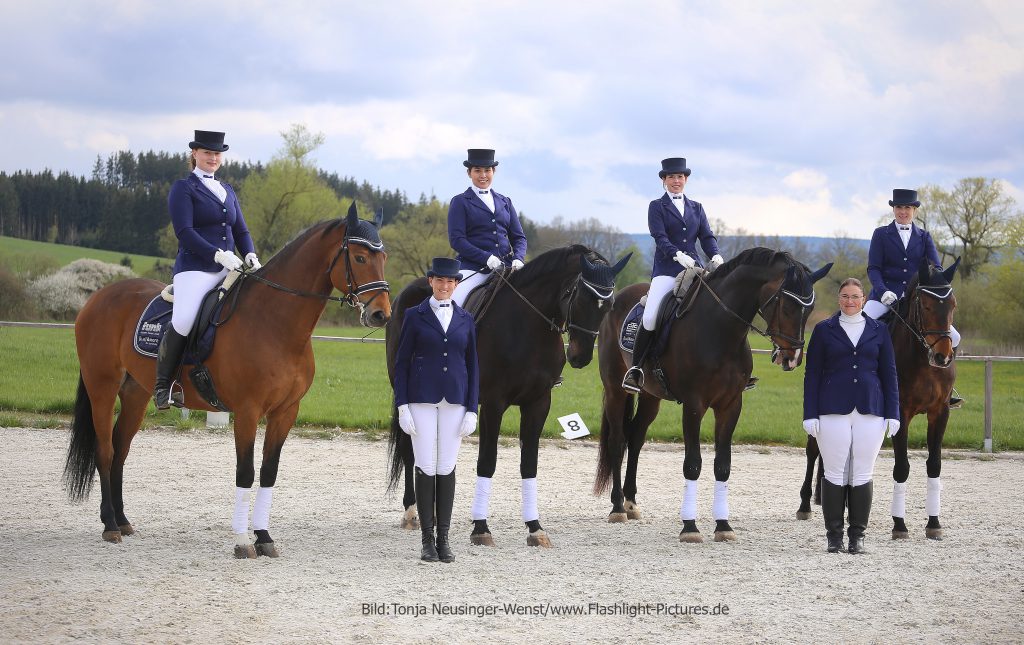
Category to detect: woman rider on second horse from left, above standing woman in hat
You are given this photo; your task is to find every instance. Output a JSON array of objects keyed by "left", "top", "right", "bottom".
[{"left": 449, "top": 148, "right": 526, "bottom": 305}]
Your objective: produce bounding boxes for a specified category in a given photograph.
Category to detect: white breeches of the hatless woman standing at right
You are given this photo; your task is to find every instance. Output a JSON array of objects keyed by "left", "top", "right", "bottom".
[{"left": 818, "top": 410, "right": 886, "bottom": 486}]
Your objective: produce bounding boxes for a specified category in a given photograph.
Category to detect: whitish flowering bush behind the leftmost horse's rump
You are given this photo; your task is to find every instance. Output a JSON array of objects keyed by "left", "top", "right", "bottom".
[{"left": 27, "top": 259, "right": 135, "bottom": 319}]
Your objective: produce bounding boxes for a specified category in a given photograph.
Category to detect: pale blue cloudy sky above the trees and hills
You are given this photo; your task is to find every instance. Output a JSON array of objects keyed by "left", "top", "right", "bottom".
[{"left": 0, "top": 0, "right": 1024, "bottom": 238}]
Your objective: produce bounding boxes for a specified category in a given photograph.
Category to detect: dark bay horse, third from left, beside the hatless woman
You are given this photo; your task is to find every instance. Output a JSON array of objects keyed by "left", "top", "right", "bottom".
[{"left": 594, "top": 248, "right": 831, "bottom": 542}]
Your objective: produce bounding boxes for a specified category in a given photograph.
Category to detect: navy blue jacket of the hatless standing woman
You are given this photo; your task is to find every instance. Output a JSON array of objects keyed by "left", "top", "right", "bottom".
[{"left": 804, "top": 313, "right": 899, "bottom": 419}]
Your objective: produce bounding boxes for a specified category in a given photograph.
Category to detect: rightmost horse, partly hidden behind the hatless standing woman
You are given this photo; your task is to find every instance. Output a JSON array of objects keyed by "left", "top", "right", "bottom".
[{"left": 797, "top": 258, "right": 959, "bottom": 540}]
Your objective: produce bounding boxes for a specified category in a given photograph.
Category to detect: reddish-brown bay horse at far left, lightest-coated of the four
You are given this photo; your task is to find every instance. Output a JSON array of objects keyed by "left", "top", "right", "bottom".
[{"left": 63, "top": 205, "right": 391, "bottom": 558}]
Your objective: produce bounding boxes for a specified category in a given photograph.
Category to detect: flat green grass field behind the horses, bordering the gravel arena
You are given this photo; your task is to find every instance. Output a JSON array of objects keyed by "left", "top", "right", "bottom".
[{"left": 0, "top": 328, "right": 1024, "bottom": 450}]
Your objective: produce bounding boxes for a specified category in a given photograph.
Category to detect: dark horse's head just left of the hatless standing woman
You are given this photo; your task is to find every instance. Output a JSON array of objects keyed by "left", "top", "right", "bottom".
[{"left": 758, "top": 254, "right": 833, "bottom": 372}]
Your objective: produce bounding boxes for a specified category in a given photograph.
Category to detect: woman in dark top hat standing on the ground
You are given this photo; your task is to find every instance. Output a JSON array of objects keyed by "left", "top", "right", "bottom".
[{"left": 394, "top": 258, "right": 480, "bottom": 562}]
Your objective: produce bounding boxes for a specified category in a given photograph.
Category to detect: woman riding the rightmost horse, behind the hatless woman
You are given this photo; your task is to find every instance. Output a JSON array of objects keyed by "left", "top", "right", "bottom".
[{"left": 864, "top": 188, "right": 963, "bottom": 407}]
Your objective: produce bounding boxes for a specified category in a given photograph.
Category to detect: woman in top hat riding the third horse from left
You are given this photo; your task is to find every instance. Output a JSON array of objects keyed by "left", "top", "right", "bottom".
[{"left": 623, "top": 157, "right": 724, "bottom": 392}]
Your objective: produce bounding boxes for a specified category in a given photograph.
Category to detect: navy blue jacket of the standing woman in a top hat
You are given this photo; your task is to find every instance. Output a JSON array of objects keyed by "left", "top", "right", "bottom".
[{"left": 394, "top": 298, "right": 480, "bottom": 413}]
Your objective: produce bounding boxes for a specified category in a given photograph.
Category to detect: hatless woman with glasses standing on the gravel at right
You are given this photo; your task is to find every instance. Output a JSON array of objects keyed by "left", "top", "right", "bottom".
[{"left": 804, "top": 277, "right": 899, "bottom": 553}]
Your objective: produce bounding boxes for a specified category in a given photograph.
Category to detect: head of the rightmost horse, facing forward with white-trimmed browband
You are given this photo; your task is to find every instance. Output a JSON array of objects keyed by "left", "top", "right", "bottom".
[{"left": 906, "top": 258, "right": 961, "bottom": 368}]
